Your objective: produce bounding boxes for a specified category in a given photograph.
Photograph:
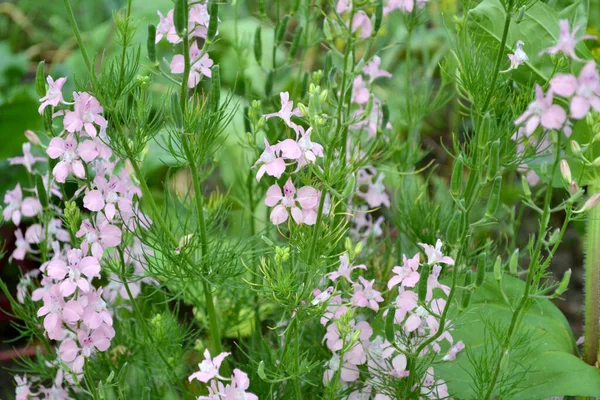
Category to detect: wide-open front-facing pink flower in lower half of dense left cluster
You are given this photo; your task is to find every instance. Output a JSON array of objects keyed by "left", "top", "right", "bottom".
[{"left": 46, "top": 249, "right": 100, "bottom": 297}]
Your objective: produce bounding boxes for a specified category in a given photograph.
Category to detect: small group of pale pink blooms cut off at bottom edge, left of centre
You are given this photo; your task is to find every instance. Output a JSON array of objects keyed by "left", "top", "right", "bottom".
[{"left": 188, "top": 349, "right": 258, "bottom": 400}]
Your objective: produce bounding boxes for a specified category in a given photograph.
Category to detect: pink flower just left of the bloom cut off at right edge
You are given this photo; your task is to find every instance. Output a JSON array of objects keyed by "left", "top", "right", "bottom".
[{"left": 515, "top": 84, "right": 567, "bottom": 135}]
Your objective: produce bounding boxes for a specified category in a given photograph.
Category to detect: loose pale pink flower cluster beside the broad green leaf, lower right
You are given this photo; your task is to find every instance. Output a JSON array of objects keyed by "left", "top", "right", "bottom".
[{"left": 321, "top": 240, "right": 464, "bottom": 400}]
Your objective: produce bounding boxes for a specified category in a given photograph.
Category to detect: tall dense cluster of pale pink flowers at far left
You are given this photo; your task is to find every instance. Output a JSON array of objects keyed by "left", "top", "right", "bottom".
[{"left": 3, "top": 77, "right": 155, "bottom": 399}]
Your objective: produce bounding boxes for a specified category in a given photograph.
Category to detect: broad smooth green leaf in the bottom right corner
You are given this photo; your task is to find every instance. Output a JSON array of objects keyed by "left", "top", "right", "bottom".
[{"left": 436, "top": 274, "right": 600, "bottom": 400}]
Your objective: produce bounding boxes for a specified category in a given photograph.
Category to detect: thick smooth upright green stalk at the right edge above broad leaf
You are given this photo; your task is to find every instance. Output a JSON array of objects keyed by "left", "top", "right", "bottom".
[{"left": 583, "top": 184, "right": 600, "bottom": 365}]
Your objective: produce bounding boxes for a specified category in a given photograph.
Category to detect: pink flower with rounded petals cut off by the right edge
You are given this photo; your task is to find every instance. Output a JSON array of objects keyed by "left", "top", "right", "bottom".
[{"left": 550, "top": 61, "right": 600, "bottom": 119}]
